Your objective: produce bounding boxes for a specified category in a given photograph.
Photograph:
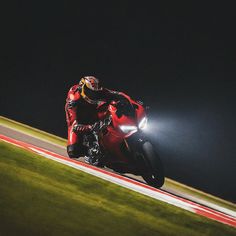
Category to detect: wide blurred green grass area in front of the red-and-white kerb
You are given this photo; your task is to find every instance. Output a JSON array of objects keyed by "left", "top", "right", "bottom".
[{"left": 0, "top": 142, "right": 236, "bottom": 236}]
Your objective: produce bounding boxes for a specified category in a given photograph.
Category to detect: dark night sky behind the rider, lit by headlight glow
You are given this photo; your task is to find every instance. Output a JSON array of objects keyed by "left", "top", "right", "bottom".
[{"left": 0, "top": 1, "right": 236, "bottom": 202}]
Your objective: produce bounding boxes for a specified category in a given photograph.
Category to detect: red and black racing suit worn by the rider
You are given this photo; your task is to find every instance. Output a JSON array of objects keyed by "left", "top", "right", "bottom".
[{"left": 65, "top": 84, "right": 127, "bottom": 158}]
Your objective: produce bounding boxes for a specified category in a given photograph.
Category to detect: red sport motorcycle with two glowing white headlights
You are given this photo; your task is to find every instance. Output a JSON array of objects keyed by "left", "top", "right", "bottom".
[{"left": 85, "top": 95, "right": 164, "bottom": 188}]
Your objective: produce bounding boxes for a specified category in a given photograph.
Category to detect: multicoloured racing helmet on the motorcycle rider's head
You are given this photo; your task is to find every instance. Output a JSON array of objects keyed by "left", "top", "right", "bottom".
[{"left": 79, "top": 76, "right": 102, "bottom": 104}]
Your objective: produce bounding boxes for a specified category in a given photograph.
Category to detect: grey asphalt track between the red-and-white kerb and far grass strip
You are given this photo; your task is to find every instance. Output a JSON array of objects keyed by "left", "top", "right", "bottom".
[{"left": 0, "top": 125, "right": 236, "bottom": 226}]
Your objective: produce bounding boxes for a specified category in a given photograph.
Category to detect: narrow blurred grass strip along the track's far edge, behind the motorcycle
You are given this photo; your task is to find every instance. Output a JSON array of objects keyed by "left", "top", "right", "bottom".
[{"left": 0, "top": 116, "right": 236, "bottom": 211}]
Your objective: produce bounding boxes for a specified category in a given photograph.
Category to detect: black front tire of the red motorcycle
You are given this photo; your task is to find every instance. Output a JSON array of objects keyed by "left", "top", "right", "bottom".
[{"left": 140, "top": 141, "right": 165, "bottom": 188}]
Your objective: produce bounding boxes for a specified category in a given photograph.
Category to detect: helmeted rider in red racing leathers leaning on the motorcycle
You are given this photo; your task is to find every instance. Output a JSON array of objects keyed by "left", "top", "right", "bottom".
[{"left": 65, "top": 76, "right": 127, "bottom": 165}]
